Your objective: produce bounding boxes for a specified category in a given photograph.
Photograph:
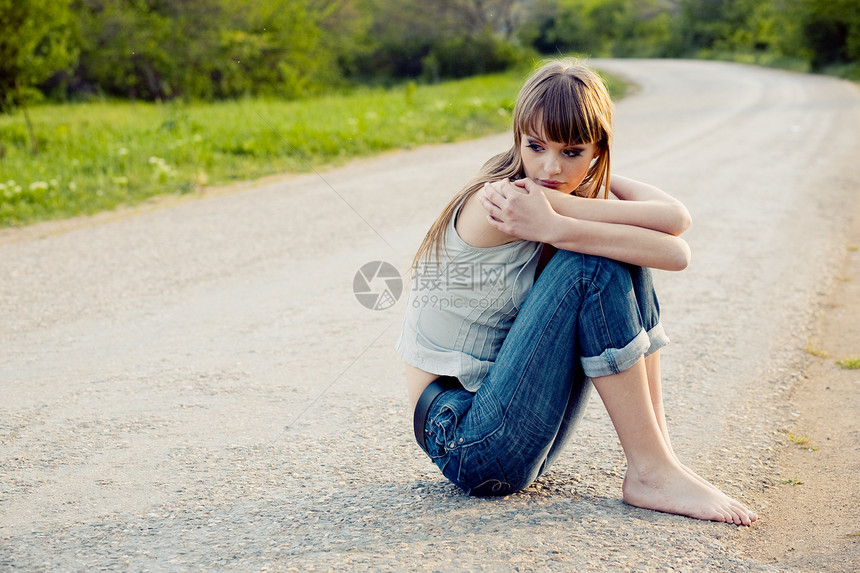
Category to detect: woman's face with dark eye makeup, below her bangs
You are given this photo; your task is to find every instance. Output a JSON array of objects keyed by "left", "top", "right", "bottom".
[{"left": 520, "top": 132, "right": 597, "bottom": 193}]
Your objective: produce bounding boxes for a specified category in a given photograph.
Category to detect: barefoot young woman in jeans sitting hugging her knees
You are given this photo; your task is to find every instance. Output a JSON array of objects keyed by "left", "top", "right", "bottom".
[{"left": 397, "top": 60, "right": 756, "bottom": 525}]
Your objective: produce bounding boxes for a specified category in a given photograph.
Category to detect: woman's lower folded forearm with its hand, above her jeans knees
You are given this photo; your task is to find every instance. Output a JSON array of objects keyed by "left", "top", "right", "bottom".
[{"left": 478, "top": 177, "right": 690, "bottom": 270}]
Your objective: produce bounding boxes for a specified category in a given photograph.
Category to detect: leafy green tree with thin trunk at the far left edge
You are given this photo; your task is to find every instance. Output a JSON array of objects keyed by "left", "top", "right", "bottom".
[{"left": 0, "top": 0, "right": 78, "bottom": 153}]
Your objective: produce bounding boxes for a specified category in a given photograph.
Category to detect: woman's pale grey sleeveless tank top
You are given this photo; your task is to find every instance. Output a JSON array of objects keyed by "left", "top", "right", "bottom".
[{"left": 395, "top": 199, "right": 541, "bottom": 392}]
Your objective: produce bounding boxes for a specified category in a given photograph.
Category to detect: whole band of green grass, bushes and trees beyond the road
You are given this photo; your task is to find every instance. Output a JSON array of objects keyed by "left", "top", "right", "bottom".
[{"left": 0, "top": 0, "right": 860, "bottom": 227}]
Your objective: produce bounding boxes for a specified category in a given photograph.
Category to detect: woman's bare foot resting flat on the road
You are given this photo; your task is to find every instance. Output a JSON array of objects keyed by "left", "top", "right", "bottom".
[{"left": 622, "top": 464, "right": 757, "bottom": 525}]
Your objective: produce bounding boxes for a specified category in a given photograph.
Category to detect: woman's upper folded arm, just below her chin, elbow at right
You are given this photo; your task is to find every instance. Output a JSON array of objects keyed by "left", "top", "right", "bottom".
[{"left": 544, "top": 175, "right": 692, "bottom": 236}]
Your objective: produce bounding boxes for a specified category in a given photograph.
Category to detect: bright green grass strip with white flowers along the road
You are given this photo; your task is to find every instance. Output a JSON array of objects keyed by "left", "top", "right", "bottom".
[{"left": 0, "top": 71, "right": 625, "bottom": 227}]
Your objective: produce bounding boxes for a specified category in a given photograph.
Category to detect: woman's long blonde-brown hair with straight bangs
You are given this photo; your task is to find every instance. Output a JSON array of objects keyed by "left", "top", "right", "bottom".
[{"left": 412, "top": 58, "right": 613, "bottom": 268}]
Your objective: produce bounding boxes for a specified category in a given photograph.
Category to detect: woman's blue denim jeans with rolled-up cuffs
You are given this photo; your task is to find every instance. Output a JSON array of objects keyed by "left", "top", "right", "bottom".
[{"left": 424, "top": 251, "right": 668, "bottom": 495}]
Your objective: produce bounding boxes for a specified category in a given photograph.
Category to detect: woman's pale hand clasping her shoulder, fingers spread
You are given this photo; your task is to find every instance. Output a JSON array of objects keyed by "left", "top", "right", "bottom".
[{"left": 478, "top": 179, "right": 559, "bottom": 243}]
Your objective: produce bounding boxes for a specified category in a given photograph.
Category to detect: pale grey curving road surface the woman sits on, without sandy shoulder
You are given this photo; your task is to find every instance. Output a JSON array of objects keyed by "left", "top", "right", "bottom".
[{"left": 5, "top": 61, "right": 860, "bottom": 571}]
